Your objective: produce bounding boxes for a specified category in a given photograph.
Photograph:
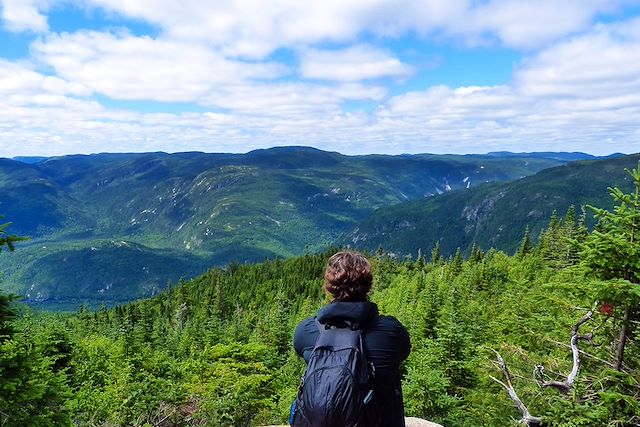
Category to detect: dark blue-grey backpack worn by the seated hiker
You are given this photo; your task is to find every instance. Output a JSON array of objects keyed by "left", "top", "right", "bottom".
[{"left": 289, "top": 323, "right": 380, "bottom": 427}]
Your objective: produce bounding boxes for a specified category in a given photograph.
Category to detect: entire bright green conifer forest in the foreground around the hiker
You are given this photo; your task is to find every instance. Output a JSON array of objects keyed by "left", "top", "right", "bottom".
[{"left": 0, "top": 168, "right": 640, "bottom": 427}]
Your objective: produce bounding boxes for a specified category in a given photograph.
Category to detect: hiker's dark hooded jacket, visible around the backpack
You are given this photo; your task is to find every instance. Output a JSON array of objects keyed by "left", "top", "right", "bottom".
[{"left": 293, "top": 301, "right": 411, "bottom": 427}]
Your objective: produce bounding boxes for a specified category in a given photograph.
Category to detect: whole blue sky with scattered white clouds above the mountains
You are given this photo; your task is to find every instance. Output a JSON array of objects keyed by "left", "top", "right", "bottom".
[{"left": 0, "top": 0, "right": 640, "bottom": 157}]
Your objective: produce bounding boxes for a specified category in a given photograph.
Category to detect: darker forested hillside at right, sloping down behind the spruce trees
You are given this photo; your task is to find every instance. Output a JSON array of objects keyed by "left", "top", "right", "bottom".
[{"left": 341, "top": 154, "right": 640, "bottom": 256}]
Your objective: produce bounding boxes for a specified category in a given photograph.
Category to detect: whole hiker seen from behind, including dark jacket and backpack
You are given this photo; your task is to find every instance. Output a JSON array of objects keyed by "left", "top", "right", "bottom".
[{"left": 291, "top": 251, "right": 411, "bottom": 427}]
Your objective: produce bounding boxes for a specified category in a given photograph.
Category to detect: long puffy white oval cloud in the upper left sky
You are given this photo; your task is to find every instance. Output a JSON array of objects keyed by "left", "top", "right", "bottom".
[{"left": 32, "top": 31, "right": 286, "bottom": 102}]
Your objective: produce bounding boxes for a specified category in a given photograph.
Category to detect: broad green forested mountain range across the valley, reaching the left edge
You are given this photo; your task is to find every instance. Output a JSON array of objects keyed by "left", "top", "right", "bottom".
[{"left": 0, "top": 147, "right": 588, "bottom": 304}]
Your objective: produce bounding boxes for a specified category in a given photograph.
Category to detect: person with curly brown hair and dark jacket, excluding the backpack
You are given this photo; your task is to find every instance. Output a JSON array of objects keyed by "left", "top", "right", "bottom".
[{"left": 293, "top": 251, "right": 411, "bottom": 427}]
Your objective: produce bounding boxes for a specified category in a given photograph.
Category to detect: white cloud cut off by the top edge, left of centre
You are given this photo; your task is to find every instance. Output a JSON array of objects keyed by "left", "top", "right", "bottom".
[{"left": 86, "top": 0, "right": 388, "bottom": 58}]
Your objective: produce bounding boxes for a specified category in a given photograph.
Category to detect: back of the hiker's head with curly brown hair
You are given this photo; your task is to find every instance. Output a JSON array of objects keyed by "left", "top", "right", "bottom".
[{"left": 324, "top": 251, "right": 373, "bottom": 301}]
